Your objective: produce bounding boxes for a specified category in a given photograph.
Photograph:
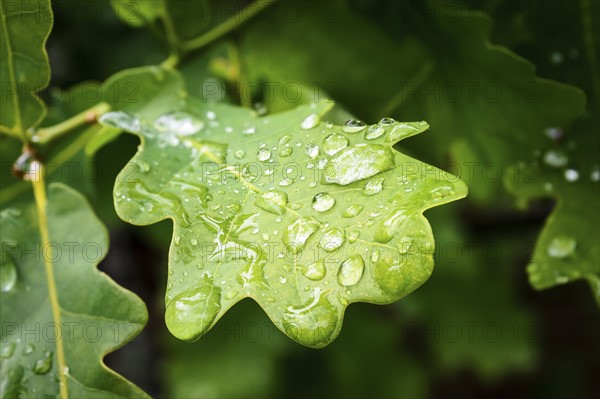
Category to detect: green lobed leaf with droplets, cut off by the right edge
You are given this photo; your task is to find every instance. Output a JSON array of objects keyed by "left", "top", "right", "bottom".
[{"left": 505, "top": 120, "right": 600, "bottom": 303}]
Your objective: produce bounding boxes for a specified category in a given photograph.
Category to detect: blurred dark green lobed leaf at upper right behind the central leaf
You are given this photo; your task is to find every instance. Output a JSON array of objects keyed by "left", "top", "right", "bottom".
[{"left": 401, "top": 4, "right": 585, "bottom": 201}]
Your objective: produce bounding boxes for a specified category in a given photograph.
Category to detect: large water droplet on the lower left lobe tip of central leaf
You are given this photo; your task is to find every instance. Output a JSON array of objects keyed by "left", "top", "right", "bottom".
[{"left": 165, "top": 282, "right": 221, "bottom": 341}]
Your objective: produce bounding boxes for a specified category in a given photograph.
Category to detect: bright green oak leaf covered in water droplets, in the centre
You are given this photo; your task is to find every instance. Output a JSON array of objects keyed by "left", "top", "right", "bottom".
[{"left": 101, "top": 101, "right": 467, "bottom": 347}]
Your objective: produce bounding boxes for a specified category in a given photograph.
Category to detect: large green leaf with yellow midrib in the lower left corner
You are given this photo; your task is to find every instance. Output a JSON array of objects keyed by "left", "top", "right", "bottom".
[{"left": 0, "top": 183, "right": 147, "bottom": 398}]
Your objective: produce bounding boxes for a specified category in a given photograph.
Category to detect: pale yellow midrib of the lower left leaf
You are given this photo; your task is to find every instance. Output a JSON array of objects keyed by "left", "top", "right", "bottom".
[{"left": 31, "top": 161, "right": 69, "bottom": 399}]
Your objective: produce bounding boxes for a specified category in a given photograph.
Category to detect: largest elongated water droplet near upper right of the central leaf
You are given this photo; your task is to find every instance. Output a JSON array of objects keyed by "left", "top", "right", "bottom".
[{"left": 323, "top": 144, "right": 395, "bottom": 186}]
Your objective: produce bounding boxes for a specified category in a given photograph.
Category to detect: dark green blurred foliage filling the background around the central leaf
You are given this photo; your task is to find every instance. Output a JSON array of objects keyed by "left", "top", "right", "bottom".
[{"left": 0, "top": 0, "right": 600, "bottom": 398}]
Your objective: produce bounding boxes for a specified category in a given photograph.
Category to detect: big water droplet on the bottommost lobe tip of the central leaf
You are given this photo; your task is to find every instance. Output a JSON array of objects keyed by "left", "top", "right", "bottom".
[{"left": 282, "top": 287, "right": 338, "bottom": 348}]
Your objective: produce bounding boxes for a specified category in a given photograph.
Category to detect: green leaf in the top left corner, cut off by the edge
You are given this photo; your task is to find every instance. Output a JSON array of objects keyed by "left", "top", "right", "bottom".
[{"left": 0, "top": 0, "right": 53, "bottom": 141}]
